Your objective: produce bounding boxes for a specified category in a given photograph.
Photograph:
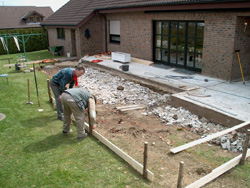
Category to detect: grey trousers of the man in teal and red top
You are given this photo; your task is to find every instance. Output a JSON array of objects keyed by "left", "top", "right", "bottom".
[{"left": 49, "top": 79, "right": 63, "bottom": 119}]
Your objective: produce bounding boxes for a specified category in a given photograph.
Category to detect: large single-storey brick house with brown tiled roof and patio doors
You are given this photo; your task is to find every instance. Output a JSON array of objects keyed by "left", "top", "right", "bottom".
[{"left": 41, "top": 0, "right": 250, "bottom": 81}]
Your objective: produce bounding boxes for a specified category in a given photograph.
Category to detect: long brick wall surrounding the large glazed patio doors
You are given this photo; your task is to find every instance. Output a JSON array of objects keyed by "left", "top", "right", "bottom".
[{"left": 107, "top": 12, "right": 250, "bottom": 81}]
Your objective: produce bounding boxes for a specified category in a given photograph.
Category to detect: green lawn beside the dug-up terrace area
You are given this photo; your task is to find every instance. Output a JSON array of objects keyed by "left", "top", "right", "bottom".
[{"left": 0, "top": 50, "right": 155, "bottom": 188}]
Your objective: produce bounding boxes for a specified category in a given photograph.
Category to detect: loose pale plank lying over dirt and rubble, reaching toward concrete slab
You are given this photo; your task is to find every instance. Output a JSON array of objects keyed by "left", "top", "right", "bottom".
[{"left": 170, "top": 121, "right": 250, "bottom": 153}]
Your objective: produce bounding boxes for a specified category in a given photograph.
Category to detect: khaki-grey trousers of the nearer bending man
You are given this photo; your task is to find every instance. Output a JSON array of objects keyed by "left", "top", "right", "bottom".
[{"left": 61, "top": 93, "right": 85, "bottom": 137}]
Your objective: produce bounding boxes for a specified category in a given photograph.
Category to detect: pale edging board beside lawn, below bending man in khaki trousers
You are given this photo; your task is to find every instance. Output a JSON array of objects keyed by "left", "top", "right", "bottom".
[{"left": 84, "top": 122, "right": 154, "bottom": 181}]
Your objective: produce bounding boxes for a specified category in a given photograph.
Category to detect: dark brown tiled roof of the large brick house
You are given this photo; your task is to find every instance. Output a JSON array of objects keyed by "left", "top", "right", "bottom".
[{"left": 41, "top": 0, "right": 250, "bottom": 28}]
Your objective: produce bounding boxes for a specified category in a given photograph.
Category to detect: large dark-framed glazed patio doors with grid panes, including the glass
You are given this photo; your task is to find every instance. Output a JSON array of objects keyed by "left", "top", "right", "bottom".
[{"left": 153, "top": 21, "right": 205, "bottom": 71}]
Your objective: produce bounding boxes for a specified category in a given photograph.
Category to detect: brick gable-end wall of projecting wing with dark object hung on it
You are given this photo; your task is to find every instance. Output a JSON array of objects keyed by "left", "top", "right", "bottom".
[{"left": 77, "top": 16, "right": 105, "bottom": 57}]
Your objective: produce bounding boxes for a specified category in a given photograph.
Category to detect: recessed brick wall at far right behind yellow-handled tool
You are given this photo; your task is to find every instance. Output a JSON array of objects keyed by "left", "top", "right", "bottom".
[{"left": 232, "top": 17, "right": 250, "bottom": 80}]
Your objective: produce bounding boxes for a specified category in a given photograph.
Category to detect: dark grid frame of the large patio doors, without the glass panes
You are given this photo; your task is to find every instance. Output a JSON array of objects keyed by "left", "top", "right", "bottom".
[{"left": 153, "top": 20, "right": 205, "bottom": 72}]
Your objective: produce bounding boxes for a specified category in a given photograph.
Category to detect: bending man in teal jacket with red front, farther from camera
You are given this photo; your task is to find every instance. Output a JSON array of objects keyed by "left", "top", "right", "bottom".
[{"left": 49, "top": 67, "right": 85, "bottom": 121}]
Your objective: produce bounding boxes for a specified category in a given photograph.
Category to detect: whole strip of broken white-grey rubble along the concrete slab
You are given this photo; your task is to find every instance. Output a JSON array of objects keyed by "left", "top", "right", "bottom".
[{"left": 79, "top": 68, "right": 246, "bottom": 152}]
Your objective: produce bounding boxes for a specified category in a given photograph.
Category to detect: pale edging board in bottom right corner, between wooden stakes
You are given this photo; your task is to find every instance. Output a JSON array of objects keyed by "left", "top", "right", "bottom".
[{"left": 186, "top": 149, "right": 250, "bottom": 188}]
